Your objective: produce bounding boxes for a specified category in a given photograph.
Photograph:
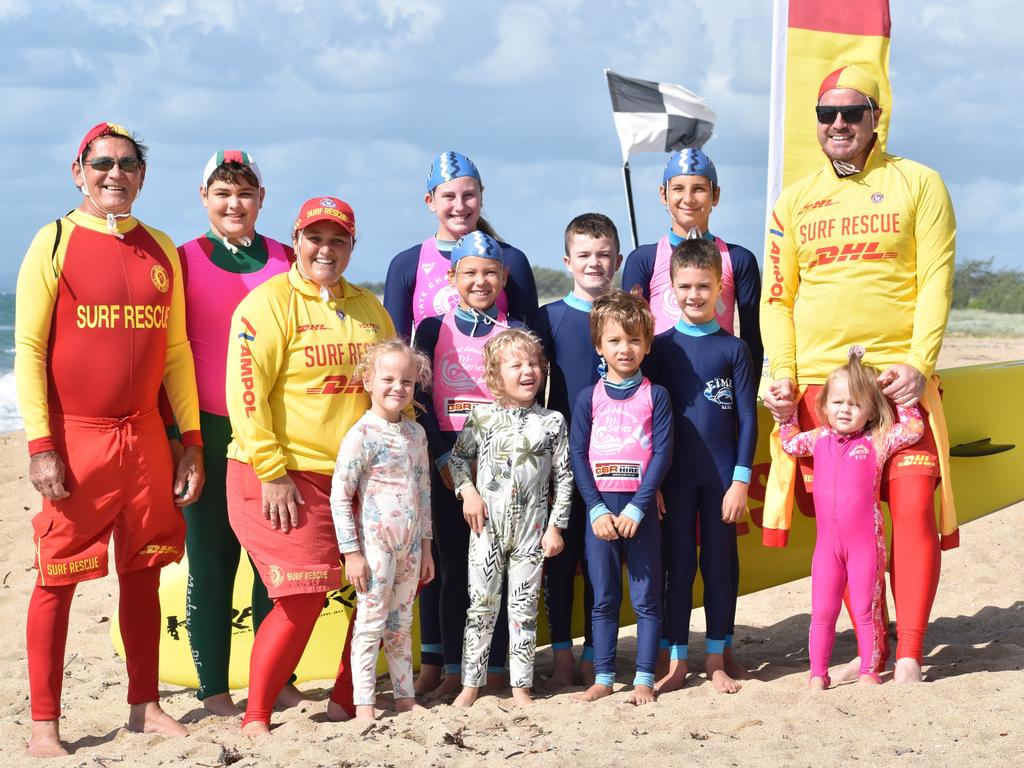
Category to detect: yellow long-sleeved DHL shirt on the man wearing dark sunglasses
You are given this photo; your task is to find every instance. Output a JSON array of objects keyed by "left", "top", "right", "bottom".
[{"left": 761, "top": 146, "right": 956, "bottom": 385}]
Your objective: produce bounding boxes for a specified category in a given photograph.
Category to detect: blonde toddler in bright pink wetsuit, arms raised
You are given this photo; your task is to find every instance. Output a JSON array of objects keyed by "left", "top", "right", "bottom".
[{"left": 779, "top": 347, "right": 924, "bottom": 689}]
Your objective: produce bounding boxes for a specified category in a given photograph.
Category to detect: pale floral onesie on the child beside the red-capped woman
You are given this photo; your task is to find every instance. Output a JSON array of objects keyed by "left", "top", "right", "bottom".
[{"left": 331, "top": 411, "right": 431, "bottom": 707}]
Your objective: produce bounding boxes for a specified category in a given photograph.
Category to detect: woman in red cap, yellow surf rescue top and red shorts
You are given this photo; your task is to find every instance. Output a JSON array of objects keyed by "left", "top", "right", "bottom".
[{"left": 226, "top": 197, "right": 394, "bottom": 735}]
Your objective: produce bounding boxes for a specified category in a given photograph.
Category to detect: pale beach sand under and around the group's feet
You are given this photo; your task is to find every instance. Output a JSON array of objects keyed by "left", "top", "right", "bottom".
[{"left": 0, "top": 344, "right": 1024, "bottom": 768}]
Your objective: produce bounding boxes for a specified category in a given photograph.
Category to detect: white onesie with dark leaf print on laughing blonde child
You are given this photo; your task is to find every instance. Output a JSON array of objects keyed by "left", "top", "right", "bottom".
[{"left": 449, "top": 403, "right": 572, "bottom": 688}]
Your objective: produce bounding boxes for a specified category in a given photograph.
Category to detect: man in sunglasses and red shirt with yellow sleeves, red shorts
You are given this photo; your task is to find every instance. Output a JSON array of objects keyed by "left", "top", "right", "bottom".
[{"left": 14, "top": 123, "right": 204, "bottom": 757}]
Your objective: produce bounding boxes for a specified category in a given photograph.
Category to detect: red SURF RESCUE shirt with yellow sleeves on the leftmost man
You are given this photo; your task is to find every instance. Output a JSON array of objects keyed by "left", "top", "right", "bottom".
[{"left": 14, "top": 211, "right": 202, "bottom": 455}]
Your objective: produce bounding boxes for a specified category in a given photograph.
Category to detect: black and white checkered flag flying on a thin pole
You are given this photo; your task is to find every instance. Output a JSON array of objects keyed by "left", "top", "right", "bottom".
[{"left": 604, "top": 70, "right": 715, "bottom": 163}]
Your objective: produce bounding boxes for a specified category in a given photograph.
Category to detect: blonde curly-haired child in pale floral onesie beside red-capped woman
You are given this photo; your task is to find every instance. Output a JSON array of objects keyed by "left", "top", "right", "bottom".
[{"left": 331, "top": 339, "right": 434, "bottom": 720}]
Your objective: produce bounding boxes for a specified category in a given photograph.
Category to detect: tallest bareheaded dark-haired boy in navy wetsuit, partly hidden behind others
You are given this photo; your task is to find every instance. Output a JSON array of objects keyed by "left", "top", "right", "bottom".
[{"left": 534, "top": 213, "right": 623, "bottom": 690}]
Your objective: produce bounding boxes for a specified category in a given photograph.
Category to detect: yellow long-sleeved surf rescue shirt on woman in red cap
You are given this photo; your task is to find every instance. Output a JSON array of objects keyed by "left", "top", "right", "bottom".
[{"left": 226, "top": 265, "right": 394, "bottom": 482}]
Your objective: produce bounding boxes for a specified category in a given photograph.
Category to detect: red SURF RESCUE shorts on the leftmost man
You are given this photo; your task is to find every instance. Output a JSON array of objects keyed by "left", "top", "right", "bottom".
[{"left": 32, "top": 409, "right": 185, "bottom": 587}]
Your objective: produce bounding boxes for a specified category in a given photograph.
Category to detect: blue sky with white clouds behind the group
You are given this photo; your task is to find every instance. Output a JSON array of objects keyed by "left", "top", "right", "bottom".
[{"left": 0, "top": 0, "right": 1024, "bottom": 291}]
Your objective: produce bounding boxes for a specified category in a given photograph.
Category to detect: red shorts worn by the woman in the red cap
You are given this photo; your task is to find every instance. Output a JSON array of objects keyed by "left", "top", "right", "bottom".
[{"left": 227, "top": 459, "right": 341, "bottom": 597}]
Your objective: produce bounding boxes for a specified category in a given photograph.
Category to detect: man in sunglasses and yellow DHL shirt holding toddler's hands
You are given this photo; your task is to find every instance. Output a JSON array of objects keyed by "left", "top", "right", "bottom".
[{"left": 761, "top": 66, "right": 958, "bottom": 682}]
